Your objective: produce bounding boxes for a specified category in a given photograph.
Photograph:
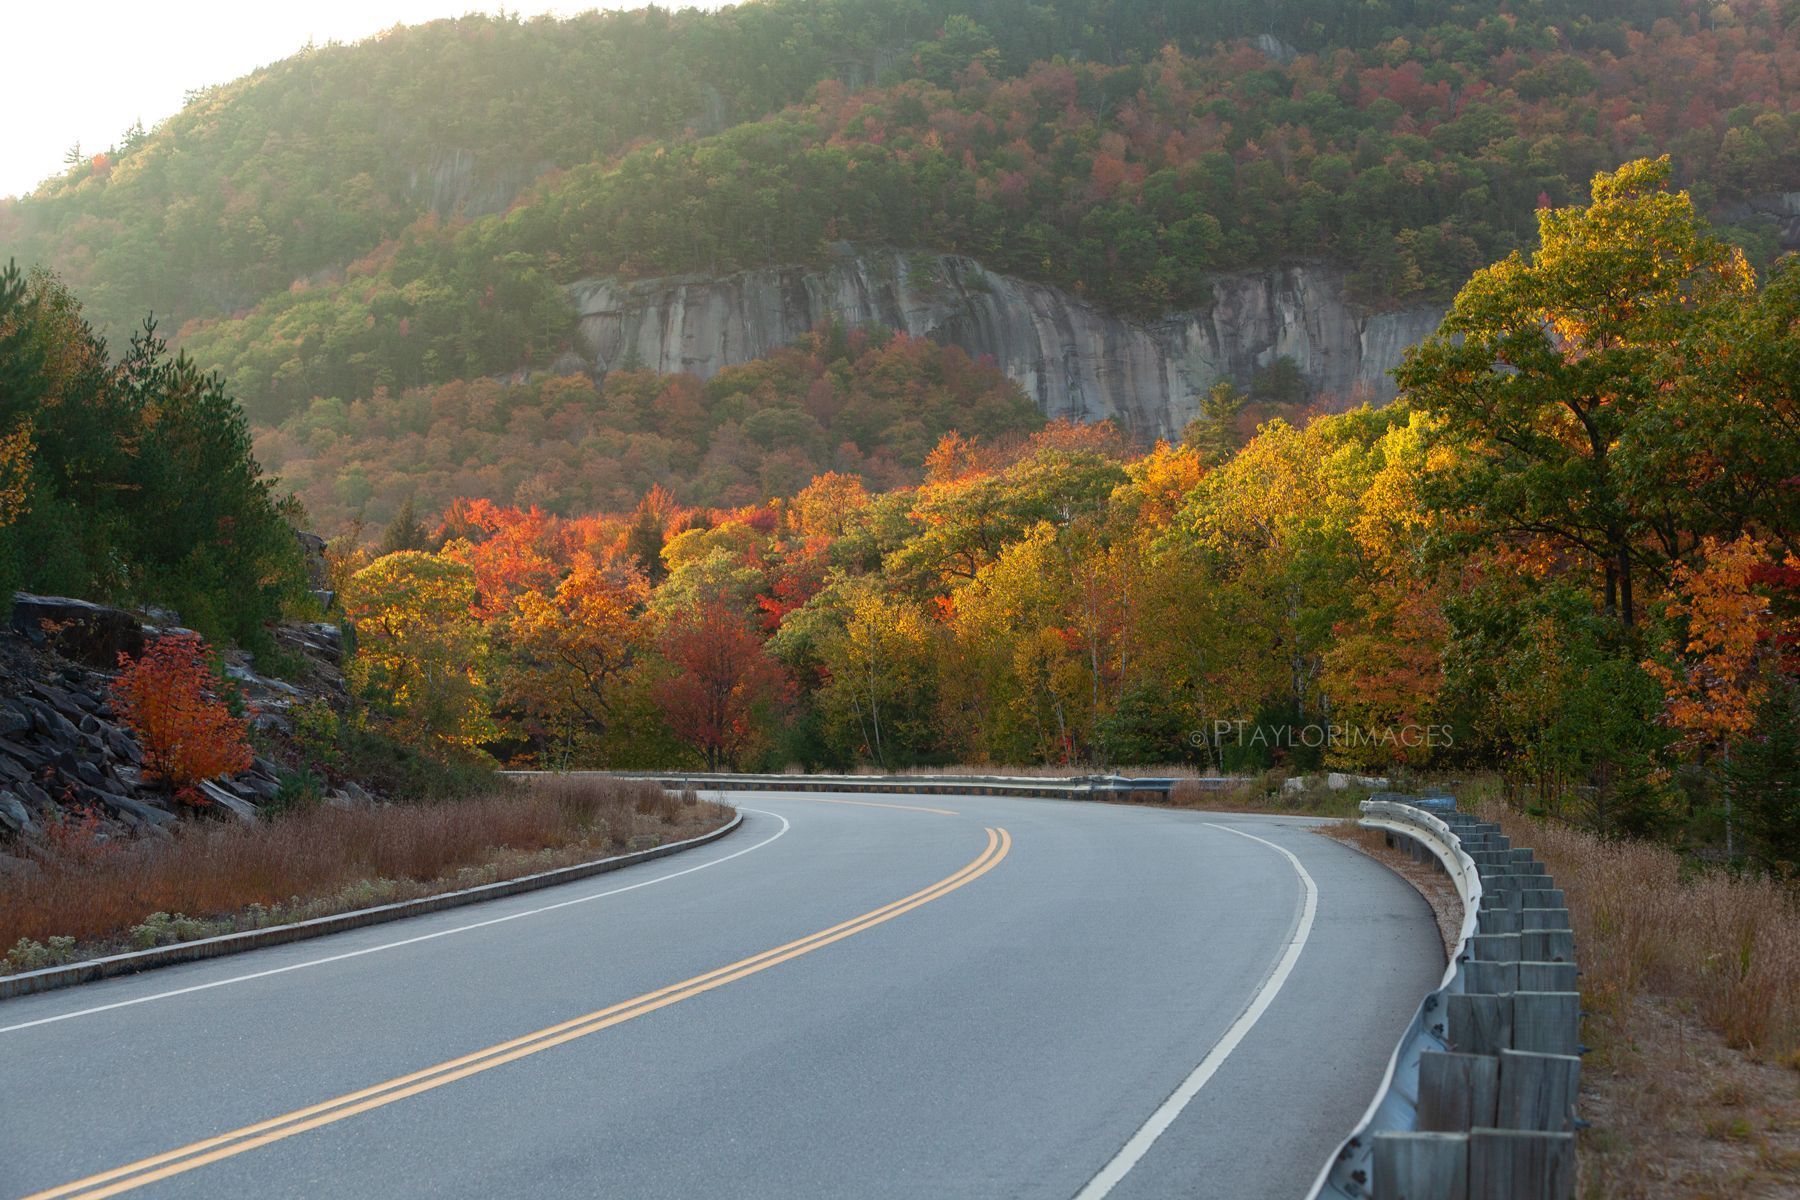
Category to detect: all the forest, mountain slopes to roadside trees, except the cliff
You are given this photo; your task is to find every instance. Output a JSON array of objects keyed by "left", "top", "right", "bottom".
[{"left": 0, "top": 0, "right": 1800, "bottom": 873}]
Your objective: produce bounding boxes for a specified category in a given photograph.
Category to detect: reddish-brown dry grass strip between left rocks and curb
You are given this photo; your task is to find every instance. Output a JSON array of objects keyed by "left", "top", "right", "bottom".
[{"left": 0, "top": 777, "right": 729, "bottom": 968}]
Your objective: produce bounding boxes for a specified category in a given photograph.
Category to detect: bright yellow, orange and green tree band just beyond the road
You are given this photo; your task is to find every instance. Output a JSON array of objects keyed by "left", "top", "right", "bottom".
[{"left": 306, "top": 160, "right": 1800, "bottom": 869}]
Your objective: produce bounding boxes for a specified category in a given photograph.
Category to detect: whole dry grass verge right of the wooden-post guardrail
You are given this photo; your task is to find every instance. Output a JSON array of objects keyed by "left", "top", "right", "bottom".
[{"left": 1460, "top": 788, "right": 1800, "bottom": 1200}]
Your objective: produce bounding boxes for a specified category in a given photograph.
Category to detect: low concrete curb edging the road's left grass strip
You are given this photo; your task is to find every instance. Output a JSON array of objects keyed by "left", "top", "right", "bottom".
[{"left": 0, "top": 813, "right": 743, "bottom": 1000}]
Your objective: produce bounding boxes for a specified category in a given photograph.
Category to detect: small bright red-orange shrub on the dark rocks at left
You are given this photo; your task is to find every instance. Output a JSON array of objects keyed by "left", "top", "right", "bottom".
[{"left": 112, "top": 633, "right": 252, "bottom": 804}]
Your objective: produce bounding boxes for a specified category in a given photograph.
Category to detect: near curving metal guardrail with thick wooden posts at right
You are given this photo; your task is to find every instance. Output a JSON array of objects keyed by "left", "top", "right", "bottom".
[{"left": 1309, "top": 793, "right": 1586, "bottom": 1200}]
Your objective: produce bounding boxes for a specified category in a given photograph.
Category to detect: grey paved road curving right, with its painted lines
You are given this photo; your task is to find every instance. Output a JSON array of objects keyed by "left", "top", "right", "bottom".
[{"left": 0, "top": 793, "right": 1442, "bottom": 1200}]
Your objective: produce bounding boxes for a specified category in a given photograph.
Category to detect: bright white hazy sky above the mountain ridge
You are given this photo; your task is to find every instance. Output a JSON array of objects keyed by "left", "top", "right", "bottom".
[{"left": 0, "top": 0, "right": 724, "bottom": 196}]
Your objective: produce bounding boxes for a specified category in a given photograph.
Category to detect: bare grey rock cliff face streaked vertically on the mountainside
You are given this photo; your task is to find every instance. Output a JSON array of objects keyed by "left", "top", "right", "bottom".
[{"left": 571, "top": 248, "right": 1444, "bottom": 441}]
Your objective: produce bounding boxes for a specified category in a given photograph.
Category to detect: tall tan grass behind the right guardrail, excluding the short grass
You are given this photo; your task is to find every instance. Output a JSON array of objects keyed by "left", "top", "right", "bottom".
[{"left": 1483, "top": 804, "right": 1800, "bottom": 1067}]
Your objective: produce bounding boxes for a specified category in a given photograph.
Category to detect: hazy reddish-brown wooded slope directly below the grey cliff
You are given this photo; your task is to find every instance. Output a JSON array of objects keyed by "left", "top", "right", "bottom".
[{"left": 257, "top": 327, "right": 1044, "bottom": 533}]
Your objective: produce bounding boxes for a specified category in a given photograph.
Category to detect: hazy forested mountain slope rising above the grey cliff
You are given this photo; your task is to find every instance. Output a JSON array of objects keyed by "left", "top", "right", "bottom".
[{"left": 0, "top": 0, "right": 1800, "bottom": 474}]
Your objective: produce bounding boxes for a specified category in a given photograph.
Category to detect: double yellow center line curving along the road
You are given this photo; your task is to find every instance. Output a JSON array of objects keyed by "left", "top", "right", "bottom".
[{"left": 25, "top": 829, "right": 1012, "bottom": 1200}]
